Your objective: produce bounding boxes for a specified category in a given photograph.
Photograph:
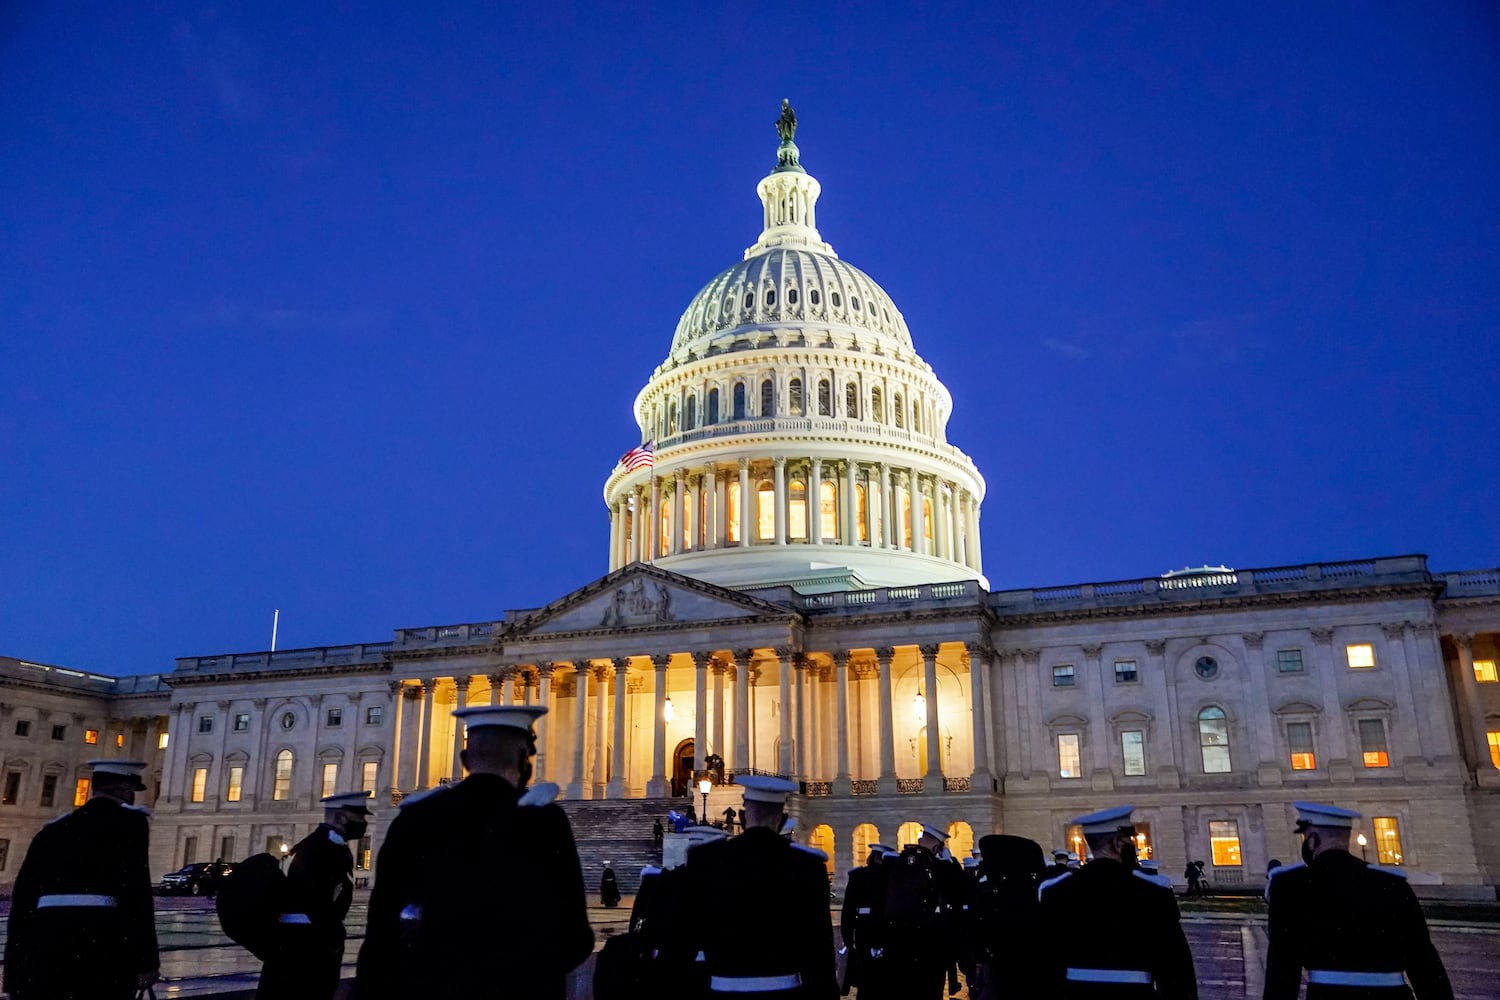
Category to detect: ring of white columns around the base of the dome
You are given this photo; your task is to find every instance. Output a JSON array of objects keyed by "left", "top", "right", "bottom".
[{"left": 609, "top": 457, "right": 984, "bottom": 573}]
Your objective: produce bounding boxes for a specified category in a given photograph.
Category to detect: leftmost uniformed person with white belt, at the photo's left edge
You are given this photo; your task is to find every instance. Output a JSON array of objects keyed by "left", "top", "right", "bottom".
[{"left": 5, "top": 760, "right": 161, "bottom": 1000}]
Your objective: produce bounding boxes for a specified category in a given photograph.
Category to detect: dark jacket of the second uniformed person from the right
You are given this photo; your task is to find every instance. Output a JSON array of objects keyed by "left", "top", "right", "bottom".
[{"left": 1040, "top": 858, "right": 1199, "bottom": 1000}]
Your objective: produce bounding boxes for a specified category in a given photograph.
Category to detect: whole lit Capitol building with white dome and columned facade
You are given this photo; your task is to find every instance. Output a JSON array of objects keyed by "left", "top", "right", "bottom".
[{"left": 0, "top": 109, "right": 1500, "bottom": 898}]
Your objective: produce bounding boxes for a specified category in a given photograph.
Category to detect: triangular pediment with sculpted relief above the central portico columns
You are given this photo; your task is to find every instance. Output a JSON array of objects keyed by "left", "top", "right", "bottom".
[{"left": 506, "top": 562, "right": 798, "bottom": 637}]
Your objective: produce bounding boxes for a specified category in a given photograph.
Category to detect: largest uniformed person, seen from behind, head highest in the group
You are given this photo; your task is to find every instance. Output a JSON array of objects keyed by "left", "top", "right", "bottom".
[{"left": 354, "top": 705, "right": 594, "bottom": 1000}]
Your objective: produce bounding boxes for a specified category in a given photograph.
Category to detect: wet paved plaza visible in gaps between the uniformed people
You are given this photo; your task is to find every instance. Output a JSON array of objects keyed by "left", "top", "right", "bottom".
[{"left": 0, "top": 892, "right": 1500, "bottom": 1000}]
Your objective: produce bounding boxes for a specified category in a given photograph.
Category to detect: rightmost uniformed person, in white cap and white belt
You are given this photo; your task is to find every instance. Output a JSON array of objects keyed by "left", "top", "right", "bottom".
[{"left": 1265, "top": 802, "right": 1454, "bottom": 1000}]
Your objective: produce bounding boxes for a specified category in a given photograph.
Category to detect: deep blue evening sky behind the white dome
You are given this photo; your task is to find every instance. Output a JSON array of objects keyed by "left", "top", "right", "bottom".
[{"left": 0, "top": 1, "right": 1500, "bottom": 673}]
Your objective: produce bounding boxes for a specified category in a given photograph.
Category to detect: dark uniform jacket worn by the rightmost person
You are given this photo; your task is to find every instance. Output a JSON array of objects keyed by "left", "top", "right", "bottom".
[{"left": 1265, "top": 850, "right": 1454, "bottom": 1000}]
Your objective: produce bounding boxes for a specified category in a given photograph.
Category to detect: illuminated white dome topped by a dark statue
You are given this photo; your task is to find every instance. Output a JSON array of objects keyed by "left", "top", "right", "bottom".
[{"left": 605, "top": 102, "right": 984, "bottom": 592}]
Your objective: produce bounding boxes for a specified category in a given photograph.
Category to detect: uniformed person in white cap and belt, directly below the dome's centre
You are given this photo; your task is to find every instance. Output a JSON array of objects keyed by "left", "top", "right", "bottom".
[{"left": 674, "top": 775, "right": 839, "bottom": 1000}]
